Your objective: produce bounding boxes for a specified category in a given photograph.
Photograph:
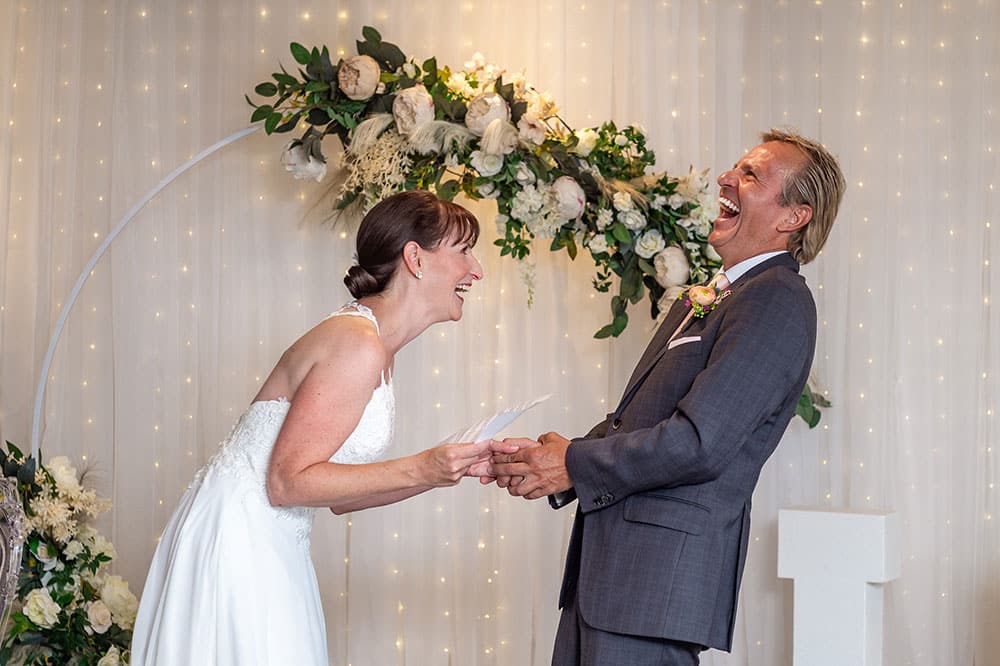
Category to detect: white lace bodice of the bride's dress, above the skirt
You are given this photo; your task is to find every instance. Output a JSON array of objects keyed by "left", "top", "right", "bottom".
[{"left": 192, "top": 303, "right": 395, "bottom": 542}]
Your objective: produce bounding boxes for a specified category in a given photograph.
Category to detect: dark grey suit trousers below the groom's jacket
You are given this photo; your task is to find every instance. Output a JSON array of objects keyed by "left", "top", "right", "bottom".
[{"left": 552, "top": 594, "right": 705, "bottom": 666}]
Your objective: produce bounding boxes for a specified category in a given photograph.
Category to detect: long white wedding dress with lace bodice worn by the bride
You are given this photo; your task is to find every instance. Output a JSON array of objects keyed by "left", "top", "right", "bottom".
[{"left": 131, "top": 303, "right": 395, "bottom": 666}]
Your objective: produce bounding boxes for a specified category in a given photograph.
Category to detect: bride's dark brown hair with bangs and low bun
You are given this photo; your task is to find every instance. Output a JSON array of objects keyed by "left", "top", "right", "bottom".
[{"left": 344, "top": 190, "right": 479, "bottom": 298}]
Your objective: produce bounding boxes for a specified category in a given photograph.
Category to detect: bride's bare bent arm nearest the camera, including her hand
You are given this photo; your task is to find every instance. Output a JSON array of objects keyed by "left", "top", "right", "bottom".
[{"left": 267, "top": 331, "right": 489, "bottom": 512}]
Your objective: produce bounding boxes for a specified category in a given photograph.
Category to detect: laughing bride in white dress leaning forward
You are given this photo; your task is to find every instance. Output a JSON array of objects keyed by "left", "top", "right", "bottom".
[{"left": 131, "top": 191, "right": 508, "bottom": 666}]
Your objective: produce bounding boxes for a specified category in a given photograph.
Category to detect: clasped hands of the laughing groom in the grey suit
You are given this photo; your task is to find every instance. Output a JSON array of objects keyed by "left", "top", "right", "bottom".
[{"left": 492, "top": 432, "right": 573, "bottom": 499}]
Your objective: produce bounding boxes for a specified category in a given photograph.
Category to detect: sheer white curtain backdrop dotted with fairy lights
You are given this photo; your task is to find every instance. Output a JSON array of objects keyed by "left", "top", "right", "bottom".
[{"left": 0, "top": 0, "right": 1000, "bottom": 666}]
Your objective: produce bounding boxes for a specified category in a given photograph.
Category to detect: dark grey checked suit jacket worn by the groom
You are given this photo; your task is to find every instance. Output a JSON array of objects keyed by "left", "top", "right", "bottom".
[{"left": 550, "top": 254, "right": 816, "bottom": 650}]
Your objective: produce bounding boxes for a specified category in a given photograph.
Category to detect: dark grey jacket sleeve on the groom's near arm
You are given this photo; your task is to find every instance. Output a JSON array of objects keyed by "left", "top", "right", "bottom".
[{"left": 566, "top": 282, "right": 816, "bottom": 513}]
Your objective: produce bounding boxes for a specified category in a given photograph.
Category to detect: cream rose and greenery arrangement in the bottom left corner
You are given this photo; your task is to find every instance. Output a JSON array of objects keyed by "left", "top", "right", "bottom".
[{"left": 0, "top": 442, "right": 139, "bottom": 666}]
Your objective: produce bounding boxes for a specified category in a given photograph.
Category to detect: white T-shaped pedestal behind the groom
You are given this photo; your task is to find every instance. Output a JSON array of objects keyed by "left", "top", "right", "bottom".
[{"left": 778, "top": 507, "right": 901, "bottom": 666}]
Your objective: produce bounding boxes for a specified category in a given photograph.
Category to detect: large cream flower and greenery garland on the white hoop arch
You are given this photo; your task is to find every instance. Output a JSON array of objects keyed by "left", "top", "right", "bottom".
[{"left": 246, "top": 27, "right": 828, "bottom": 427}]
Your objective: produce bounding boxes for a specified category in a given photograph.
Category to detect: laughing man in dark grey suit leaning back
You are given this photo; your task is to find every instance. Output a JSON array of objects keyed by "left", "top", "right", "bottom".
[{"left": 492, "top": 130, "right": 845, "bottom": 666}]
